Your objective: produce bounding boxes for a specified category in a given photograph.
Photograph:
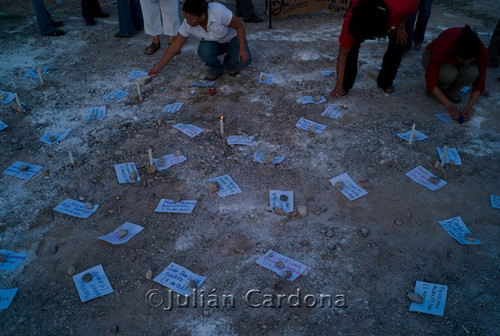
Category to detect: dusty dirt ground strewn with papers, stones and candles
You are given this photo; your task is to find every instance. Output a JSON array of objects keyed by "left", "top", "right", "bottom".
[{"left": 0, "top": 0, "right": 500, "bottom": 335}]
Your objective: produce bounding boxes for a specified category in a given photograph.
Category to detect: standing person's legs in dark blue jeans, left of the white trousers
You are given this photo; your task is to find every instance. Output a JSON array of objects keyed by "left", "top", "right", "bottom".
[{"left": 115, "top": 0, "right": 144, "bottom": 37}]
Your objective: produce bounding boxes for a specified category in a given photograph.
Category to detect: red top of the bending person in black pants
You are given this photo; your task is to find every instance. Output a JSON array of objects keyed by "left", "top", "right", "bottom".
[{"left": 339, "top": 0, "right": 419, "bottom": 49}]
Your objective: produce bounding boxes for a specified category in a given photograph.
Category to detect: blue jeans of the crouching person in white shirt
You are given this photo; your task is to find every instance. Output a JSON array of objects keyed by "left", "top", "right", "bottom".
[{"left": 198, "top": 36, "right": 252, "bottom": 76}]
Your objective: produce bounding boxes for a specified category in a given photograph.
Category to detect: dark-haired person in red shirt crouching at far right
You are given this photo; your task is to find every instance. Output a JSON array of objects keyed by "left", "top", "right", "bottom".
[{"left": 422, "top": 25, "right": 488, "bottom": 123}]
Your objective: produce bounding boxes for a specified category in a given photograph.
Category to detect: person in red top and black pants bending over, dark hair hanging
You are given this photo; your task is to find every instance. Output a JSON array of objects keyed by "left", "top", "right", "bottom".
[{"left": 330, "top": 0, "right": 418, "bottom": 98}]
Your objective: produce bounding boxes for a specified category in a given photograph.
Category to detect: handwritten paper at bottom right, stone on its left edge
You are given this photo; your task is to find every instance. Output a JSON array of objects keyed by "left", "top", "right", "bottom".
[{"left": 410, "top": 281, "right": 448, "bottom": 316}]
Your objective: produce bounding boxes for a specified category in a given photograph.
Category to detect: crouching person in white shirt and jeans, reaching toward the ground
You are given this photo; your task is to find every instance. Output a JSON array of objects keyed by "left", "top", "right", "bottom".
[{"left": 148, "top": 0, "right": 251, "bottom": 80}]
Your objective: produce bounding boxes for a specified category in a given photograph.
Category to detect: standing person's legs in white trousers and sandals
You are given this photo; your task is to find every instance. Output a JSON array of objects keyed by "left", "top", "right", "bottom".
[{"left": 141, "top": 0, "right": 179, "bottom": 55}]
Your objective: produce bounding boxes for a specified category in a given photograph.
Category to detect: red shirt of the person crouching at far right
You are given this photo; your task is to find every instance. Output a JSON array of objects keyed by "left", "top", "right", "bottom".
[{"left": 425, "top": 27, "right": 488, "bottom": 92}]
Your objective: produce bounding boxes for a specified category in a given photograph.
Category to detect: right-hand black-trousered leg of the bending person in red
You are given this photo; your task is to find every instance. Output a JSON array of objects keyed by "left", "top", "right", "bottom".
[{"left": 377, "top": 34, "right": 406, "bottom": 93}]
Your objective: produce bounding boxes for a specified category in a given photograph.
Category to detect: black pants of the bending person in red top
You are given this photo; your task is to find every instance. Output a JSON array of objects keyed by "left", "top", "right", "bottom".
[{"left": 343, "top": 34, "right": 406, "bottom": 90}]
